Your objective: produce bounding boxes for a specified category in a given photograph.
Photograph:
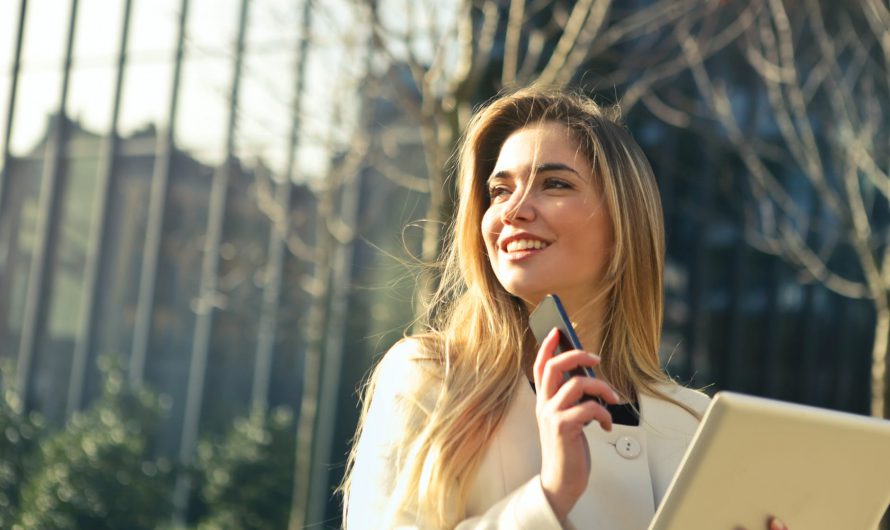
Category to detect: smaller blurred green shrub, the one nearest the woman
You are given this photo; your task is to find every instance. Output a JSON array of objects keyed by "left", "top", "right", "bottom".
[{"left": 195, "top": 407, "right": 295, "bottom": 530}]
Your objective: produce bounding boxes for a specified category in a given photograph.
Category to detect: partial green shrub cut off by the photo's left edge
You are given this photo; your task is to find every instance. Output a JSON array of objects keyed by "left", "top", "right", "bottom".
[{"left": 0, "top": 356, "right": 44, "bottom": 528}]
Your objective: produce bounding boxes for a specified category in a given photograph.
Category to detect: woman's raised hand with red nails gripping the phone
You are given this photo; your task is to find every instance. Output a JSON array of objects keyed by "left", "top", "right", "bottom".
[{"left": 534, "top": 329, "right": 618, "bottom": 521}]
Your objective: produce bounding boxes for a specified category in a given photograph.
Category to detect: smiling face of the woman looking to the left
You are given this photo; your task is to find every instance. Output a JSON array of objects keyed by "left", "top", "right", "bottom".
[{"left": 482, "top": 122, "right": 612, "bottom": 308}]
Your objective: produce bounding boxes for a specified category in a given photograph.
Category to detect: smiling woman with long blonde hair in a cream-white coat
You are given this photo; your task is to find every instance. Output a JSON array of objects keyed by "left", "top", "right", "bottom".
[{"left": 343, "top": 89, "right": 781, "bottom": 530}]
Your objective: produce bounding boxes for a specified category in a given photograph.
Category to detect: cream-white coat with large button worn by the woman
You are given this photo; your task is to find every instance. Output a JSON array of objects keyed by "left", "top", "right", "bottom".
[{"left": 346, "top": 341, "right": 709, "bottom": 530}]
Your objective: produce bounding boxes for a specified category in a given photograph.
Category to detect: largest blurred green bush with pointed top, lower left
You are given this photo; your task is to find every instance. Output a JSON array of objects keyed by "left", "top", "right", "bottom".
[{"left": 15, "top": 356, "right": 173, "bottom": 530}]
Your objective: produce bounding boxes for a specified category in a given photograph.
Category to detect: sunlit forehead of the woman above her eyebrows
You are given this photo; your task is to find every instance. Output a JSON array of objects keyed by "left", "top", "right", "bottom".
[{"left": 493, "top": 122, "right": 588, "bottom": 173}]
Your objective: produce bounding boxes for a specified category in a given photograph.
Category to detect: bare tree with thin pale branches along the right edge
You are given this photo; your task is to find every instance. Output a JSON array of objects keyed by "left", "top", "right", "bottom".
[{"left": 676, "top": 0, "right": 890, "bottom": 417}]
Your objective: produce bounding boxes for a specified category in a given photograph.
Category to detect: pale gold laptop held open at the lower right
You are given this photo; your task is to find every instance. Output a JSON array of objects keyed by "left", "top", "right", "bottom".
[{"left": 649, "top": 392, "right": 890, "bottom": 530}]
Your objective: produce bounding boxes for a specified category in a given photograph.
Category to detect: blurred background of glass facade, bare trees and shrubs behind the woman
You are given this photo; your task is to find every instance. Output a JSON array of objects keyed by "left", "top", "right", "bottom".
[{"left": 0, "top": 0, "right": 890, "bottom": 530}]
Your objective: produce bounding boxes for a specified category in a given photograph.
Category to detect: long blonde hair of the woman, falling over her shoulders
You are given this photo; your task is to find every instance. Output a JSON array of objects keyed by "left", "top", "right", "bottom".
[{"left": 342, "top": 88, "right": 695, "bottom": 527}]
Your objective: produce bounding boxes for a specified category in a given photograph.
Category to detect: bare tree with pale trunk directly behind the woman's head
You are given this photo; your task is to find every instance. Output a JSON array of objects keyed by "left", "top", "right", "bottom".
[{"left": 359, "top": 0, "right": 747, "bottom": 310}]
